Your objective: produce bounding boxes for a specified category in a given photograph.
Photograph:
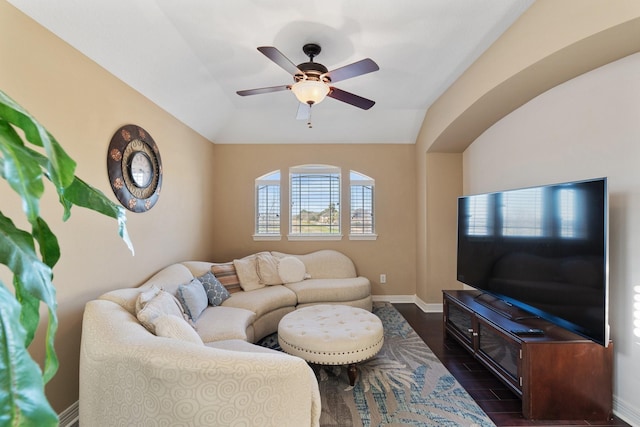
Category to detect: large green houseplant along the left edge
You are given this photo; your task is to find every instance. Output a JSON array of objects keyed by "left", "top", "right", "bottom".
[{"left": 0, "top": 91, "right": 133, "bottom": 426}]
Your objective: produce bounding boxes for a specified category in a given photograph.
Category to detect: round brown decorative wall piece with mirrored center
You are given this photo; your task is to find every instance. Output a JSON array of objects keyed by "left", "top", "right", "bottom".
[{"left": 107, "top": 125, "right": 162, "bottom": 212}]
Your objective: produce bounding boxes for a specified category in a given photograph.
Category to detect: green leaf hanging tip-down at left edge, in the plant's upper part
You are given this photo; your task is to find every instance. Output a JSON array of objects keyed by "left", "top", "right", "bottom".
[{"left": 0, "top": 120, "right": 44, "bottom": 222}]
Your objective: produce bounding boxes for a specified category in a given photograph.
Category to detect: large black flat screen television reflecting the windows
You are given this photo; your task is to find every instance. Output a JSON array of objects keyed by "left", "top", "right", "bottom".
[{"left": 457, "top": 178, "right": 609, "bottom": 346}]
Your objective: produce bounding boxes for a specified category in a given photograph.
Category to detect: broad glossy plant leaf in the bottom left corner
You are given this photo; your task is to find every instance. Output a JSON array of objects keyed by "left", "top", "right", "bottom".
[{"left": 0, "top": 282, "right": 58, "bottom": 427}]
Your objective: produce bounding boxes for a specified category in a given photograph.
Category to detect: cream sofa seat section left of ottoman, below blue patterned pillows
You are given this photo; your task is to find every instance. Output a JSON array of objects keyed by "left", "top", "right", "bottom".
[{"left": 196, "top": 306, "right": 256, "bottom": 343}]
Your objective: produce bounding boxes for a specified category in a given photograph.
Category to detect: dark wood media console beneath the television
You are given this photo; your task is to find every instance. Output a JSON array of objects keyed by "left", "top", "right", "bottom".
[{"left": 443, "top": 291, "right": 613, "bottom": 420}]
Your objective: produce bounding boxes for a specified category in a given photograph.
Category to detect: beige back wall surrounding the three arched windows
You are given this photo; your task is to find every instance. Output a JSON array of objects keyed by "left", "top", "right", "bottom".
[{"left": 211, "top": 144, "right": 416, "bottom": 295}]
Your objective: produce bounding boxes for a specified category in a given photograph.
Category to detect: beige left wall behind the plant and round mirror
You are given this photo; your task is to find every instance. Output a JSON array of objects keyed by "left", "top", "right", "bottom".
[{"left": 0, "top": 0, "right": 214, "bottom": 411}]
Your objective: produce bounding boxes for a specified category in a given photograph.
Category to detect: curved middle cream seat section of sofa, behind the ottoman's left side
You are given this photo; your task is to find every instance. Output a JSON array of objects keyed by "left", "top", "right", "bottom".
[{"left": 222, "top": 285, "right": 297, "bottom": 317}]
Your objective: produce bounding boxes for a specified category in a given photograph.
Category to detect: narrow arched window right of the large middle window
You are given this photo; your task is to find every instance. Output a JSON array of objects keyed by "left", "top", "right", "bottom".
[{"left": 349, "top": 171, "right": 375, "bottom": 239}]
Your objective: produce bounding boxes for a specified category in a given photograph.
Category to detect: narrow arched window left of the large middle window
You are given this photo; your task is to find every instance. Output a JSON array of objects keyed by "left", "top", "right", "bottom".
[{"left": 254, "top": 171, "right": 280, "bottom": 239}]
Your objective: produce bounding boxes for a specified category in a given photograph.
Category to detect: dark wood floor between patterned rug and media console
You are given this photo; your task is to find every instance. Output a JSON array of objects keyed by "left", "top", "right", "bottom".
[{"left": 394, "top": 304, "right": 629, "bottom": 427}]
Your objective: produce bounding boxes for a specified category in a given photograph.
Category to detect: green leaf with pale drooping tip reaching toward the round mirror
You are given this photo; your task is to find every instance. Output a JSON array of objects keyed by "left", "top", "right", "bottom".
[{"left": 63, "top": 177, "right": 135, "bottom": 254}]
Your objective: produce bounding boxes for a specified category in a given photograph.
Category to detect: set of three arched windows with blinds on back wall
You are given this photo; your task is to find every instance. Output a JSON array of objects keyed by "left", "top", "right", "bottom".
[{"left": 253, "top": 165, "right": 377, "bottom": 240}]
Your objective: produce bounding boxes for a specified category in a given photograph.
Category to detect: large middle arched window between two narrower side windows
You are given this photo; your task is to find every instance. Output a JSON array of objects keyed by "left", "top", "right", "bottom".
[{"left": 289, "top": 165, "right": 341, "bottom": 238}]
